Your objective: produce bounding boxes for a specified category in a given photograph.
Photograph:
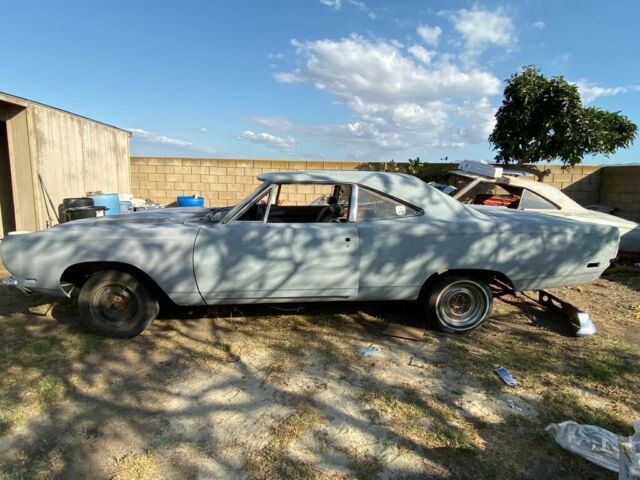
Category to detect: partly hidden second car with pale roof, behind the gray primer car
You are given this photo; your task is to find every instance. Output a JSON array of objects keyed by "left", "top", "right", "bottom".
[{"left": 436, "top": 166, "right": 640, "bottom": 258}]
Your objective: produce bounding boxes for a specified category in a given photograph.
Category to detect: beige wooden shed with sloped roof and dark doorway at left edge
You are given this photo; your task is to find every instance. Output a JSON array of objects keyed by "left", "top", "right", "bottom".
[{"left": 0, "top": 92, "right": 131, "bottom": 238}]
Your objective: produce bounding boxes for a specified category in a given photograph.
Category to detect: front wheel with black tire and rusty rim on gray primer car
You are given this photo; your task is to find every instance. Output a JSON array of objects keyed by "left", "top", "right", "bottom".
[{"left": 78, "top": 270, "right": 160, "bottom": 338}]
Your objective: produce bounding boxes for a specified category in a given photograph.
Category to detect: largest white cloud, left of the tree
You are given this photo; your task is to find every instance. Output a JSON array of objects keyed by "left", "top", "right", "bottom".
[{"left": 270, "top": 35, "right": 500, "bottom": 158}]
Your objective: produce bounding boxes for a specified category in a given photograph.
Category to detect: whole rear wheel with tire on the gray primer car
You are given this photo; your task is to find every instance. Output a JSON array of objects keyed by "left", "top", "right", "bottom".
[{"left": 427, "top": 275, "right": 493, "bottom": 333}]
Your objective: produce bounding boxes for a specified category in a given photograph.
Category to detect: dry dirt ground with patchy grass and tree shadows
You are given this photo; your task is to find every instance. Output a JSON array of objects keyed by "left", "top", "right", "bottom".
[{"left": 0, "top": 260, "right": 640, "bottom": 479}]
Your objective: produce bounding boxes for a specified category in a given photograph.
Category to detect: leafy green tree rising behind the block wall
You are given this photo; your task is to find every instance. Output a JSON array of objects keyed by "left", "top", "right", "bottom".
[{"left": 489, "top": 66, "right": 638, "bottom": 165}]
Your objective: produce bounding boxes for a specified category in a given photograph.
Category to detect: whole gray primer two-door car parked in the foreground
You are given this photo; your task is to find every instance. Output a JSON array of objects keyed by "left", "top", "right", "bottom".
[{"left": 1, "top": 171, "right": 619, "bottom": 337}]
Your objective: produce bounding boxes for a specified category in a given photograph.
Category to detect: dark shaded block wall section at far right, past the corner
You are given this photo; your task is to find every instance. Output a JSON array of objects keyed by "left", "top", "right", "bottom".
[{"left": 600, "top": 165, "right": 640, "bottom": 222}]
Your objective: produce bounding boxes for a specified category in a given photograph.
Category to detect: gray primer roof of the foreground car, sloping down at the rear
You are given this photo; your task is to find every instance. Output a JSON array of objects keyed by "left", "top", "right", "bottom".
[{"left": 258, "top": 170, "right": 474, "bottom": 220}]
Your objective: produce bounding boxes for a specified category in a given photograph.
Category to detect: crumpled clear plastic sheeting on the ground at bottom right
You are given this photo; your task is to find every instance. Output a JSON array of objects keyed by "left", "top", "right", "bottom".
[{"left": 545, "top": 421, "right": 640, "bottom": 480}]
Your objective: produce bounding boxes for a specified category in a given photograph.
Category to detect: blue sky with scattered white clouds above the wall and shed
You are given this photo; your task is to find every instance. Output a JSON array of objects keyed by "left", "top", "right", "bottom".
[{"left": 0, "top": 0, "right": 640, "bottom": 164}]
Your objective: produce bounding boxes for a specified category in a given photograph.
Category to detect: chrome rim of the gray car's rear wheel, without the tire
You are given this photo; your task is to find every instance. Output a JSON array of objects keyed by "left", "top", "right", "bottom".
[{"left": 436, "top": 280, "right": 489, "bottom": 330}]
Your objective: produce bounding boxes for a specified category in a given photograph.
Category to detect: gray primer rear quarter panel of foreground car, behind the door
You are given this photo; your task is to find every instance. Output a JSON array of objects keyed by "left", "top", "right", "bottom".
[{"left": 358, "top": 214, "right": 618, "bottom": 300}]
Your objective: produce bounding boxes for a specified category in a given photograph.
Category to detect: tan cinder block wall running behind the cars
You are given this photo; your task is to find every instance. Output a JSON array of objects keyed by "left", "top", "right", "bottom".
[{"left": 131, "top": 157, "right": 640, "bottom": 219}]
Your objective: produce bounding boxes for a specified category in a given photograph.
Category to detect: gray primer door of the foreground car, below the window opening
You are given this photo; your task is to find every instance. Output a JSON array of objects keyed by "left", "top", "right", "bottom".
[{"left": 194, "top": 188, "right": 359, "bottom": 304}]
